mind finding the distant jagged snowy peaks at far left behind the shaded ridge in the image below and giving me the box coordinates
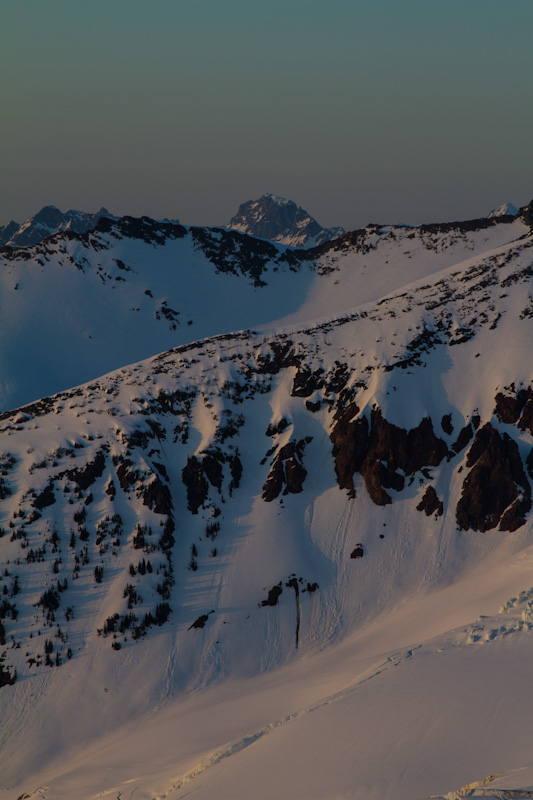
[0,206,117,247]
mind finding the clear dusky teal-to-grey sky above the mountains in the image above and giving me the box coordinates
[0,0,533,229]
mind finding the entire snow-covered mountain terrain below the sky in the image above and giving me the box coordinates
[0,195,533,800]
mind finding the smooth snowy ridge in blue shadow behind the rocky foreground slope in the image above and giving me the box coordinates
[0,212,529,410]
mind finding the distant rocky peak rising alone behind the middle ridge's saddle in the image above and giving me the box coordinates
[227,194,346,247]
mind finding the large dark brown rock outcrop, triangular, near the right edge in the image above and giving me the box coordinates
[456,422,531,532]
